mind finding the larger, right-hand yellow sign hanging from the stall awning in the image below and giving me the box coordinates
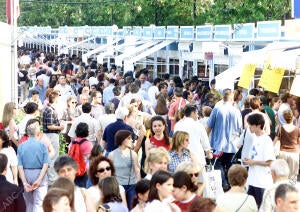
[258,66,285,93]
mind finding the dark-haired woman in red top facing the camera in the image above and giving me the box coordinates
[145,116,171,155]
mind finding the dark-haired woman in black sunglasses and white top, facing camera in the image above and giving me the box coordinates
[87,156,127,209]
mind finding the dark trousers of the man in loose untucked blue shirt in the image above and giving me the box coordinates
[213,152,234,186]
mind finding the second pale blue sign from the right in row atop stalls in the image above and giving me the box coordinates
[233,23,255,41]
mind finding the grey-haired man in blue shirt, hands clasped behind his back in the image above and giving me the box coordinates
[17,119,50,211]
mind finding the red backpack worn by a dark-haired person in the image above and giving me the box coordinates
[68,138,87,177]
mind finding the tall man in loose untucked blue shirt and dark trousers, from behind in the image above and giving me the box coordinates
[206,89,242,190]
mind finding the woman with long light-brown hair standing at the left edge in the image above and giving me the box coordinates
[2,102,19,150]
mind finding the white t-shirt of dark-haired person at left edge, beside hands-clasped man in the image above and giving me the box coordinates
[0,146,18,183]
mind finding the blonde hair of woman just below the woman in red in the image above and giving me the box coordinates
[144,147,170,173]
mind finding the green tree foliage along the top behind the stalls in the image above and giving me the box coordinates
[0,0,290,27]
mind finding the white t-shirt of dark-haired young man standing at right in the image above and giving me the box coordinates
[247,134,276,188]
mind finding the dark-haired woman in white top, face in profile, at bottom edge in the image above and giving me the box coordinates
[145,170,180,212]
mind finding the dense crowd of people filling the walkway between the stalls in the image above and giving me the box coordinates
[0,49,300,212]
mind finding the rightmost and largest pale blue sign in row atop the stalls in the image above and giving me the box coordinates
[256,21,281,40]
